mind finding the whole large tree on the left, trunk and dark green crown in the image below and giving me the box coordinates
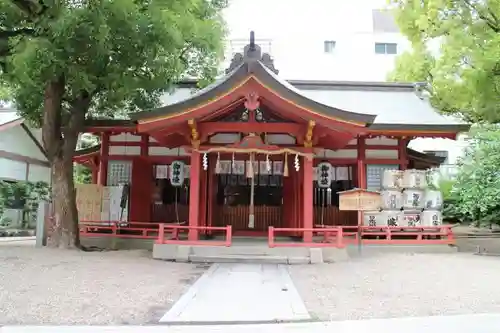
[0,0,225,248]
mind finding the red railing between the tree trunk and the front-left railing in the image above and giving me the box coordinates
[78,221,159,239]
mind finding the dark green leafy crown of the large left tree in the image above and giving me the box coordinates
[0,0,226,123]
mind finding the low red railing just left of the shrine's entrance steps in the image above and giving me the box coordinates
[156,223,233,246]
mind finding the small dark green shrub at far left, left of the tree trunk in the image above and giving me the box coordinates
[0,181,49,224]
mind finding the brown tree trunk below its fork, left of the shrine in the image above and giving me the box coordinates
[47,154,80,249]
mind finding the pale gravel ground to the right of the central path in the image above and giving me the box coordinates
[290,253,500,320]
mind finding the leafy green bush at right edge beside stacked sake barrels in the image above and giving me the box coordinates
[451,125,500,225]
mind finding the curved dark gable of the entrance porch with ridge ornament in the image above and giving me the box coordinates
[130,33,376,127]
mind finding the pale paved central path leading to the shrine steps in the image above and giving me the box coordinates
[160,264,311,323]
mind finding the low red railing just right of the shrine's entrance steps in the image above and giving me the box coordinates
[268,226,345,248]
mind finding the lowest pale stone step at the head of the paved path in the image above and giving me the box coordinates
[189,254,310,264]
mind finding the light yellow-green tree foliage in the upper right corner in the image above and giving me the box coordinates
[389,0,500,123]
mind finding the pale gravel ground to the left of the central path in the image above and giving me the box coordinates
[0,244,206,325]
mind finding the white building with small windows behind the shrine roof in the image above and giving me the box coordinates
[223,0,467,172]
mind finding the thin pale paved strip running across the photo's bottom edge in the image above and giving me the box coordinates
[0,314,500,333]
